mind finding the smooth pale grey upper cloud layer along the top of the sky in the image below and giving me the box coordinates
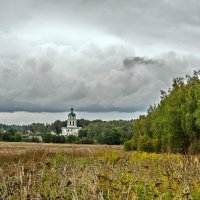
[0,0,200,52]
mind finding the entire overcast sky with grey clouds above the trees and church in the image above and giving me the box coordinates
[0,0,200,124]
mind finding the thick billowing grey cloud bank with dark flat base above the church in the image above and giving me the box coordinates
[0,44,199,112]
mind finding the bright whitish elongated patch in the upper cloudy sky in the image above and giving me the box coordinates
[16,22,122,47]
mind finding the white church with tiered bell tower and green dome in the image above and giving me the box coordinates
[61,108,81,136]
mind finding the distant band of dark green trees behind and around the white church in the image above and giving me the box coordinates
[0,119,133,145]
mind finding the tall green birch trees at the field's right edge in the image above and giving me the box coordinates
[124,71,200,153]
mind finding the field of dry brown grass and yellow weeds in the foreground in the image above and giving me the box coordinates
[0,143,200,200]
